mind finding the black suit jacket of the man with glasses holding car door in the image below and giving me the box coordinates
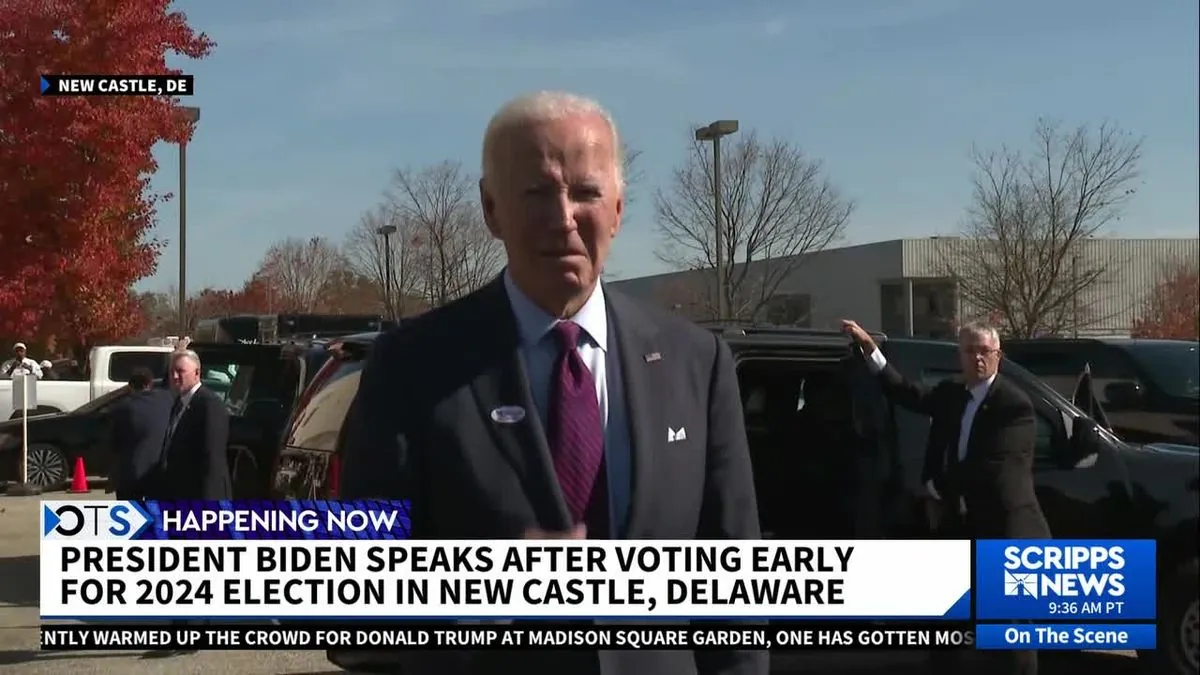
[880,364,1050,539]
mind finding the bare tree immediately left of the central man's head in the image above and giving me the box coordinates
[389,162,504,306]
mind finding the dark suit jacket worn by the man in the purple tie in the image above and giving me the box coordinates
[342,279,767,675]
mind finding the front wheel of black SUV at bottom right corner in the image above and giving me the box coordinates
[1138,560,1200,675]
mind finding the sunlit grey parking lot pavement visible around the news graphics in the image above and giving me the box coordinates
[0,491,1136,675]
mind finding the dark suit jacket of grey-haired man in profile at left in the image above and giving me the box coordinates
[155,386,233,500]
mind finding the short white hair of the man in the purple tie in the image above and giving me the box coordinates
[481,91,625,187]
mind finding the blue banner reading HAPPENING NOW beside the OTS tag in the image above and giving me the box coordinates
[137,500,409,539]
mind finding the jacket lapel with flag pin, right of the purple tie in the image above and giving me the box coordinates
[605,288,671,537]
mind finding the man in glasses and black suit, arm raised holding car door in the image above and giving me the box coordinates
[842,321,1050,675]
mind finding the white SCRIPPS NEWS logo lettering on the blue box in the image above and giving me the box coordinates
[1004,544,1126,598]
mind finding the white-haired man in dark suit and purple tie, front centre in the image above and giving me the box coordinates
[342,92,767,675]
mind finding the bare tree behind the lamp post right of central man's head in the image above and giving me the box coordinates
[654,132,853,319]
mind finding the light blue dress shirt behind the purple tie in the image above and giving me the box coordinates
[504,270,632,538]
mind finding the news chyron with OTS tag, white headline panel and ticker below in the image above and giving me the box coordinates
[40,501,973,649]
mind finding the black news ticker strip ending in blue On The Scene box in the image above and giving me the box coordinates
[41,622,1157,651]
